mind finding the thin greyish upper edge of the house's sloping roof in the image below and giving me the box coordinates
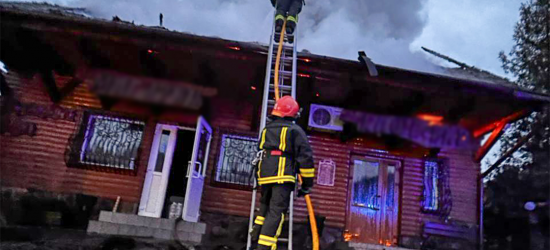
[0,2,550,107]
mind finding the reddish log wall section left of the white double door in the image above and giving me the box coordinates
[0,71,197,204]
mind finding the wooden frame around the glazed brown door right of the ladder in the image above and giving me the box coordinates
[350,153,405,246]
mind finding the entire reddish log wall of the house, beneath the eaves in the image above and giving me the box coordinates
[0,71,479,241]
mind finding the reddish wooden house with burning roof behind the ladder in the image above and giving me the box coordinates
[0,3,550,249]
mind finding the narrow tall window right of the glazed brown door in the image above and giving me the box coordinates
[422,159,440,212]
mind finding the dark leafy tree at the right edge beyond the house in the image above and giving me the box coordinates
[484,0,550,249]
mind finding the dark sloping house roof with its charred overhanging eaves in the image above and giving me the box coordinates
[0,2,550,133]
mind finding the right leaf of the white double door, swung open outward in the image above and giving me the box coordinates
[182,116,212,222]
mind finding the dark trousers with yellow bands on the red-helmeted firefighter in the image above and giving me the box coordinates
[254,183,294,250]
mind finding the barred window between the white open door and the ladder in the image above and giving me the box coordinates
[215,134,258,187]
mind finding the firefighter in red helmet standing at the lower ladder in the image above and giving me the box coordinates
[251,96,315,250]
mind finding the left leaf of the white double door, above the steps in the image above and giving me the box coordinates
[138,124,178,218]
